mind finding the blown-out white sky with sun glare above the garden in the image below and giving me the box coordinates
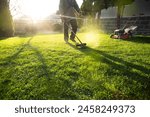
[11,0,83,20]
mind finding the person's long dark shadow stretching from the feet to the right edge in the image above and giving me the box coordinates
[69,44,150,77]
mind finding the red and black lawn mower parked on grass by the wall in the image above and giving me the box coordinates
[110,17,138,39]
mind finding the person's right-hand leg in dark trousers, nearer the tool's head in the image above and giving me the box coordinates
[70,19,78,41]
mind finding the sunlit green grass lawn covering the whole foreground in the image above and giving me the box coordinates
[0,33,150,100]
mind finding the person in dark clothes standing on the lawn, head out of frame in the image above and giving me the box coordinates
[59,0,80,43]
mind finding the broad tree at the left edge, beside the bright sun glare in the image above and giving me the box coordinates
[0,0,14,37]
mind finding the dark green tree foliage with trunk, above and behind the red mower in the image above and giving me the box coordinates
[81,0,134,28]
